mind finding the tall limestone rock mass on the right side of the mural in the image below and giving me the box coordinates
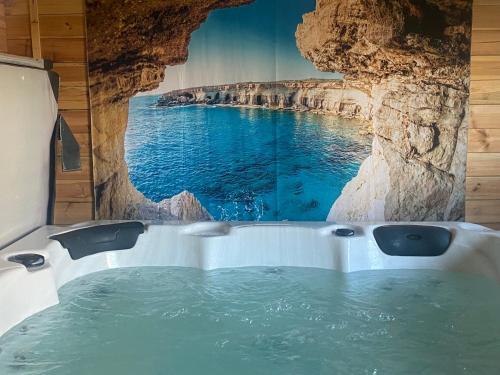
[296,0,472,221]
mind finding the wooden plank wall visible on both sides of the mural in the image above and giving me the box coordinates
[0,0,500,229]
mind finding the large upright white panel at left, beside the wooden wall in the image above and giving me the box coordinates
[0,54,57,247]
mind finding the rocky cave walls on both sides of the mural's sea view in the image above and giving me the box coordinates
[87,0,472,221]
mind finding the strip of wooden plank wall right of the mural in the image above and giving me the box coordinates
[466,0,500,229]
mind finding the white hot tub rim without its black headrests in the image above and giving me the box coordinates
[0,222,500,335]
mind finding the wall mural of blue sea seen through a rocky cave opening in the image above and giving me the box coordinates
[86,0,472,221]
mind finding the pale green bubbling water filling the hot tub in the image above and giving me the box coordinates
[0,267,500,375]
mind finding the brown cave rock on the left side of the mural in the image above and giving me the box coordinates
[86,0,253,220]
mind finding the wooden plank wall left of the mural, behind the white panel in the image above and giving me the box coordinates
[4,0,93,224]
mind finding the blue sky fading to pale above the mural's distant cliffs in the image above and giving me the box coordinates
[146,0,341,95]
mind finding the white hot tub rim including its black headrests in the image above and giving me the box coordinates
[0,222,500,373]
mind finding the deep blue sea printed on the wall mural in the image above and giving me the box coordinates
[125,96,371,220]
